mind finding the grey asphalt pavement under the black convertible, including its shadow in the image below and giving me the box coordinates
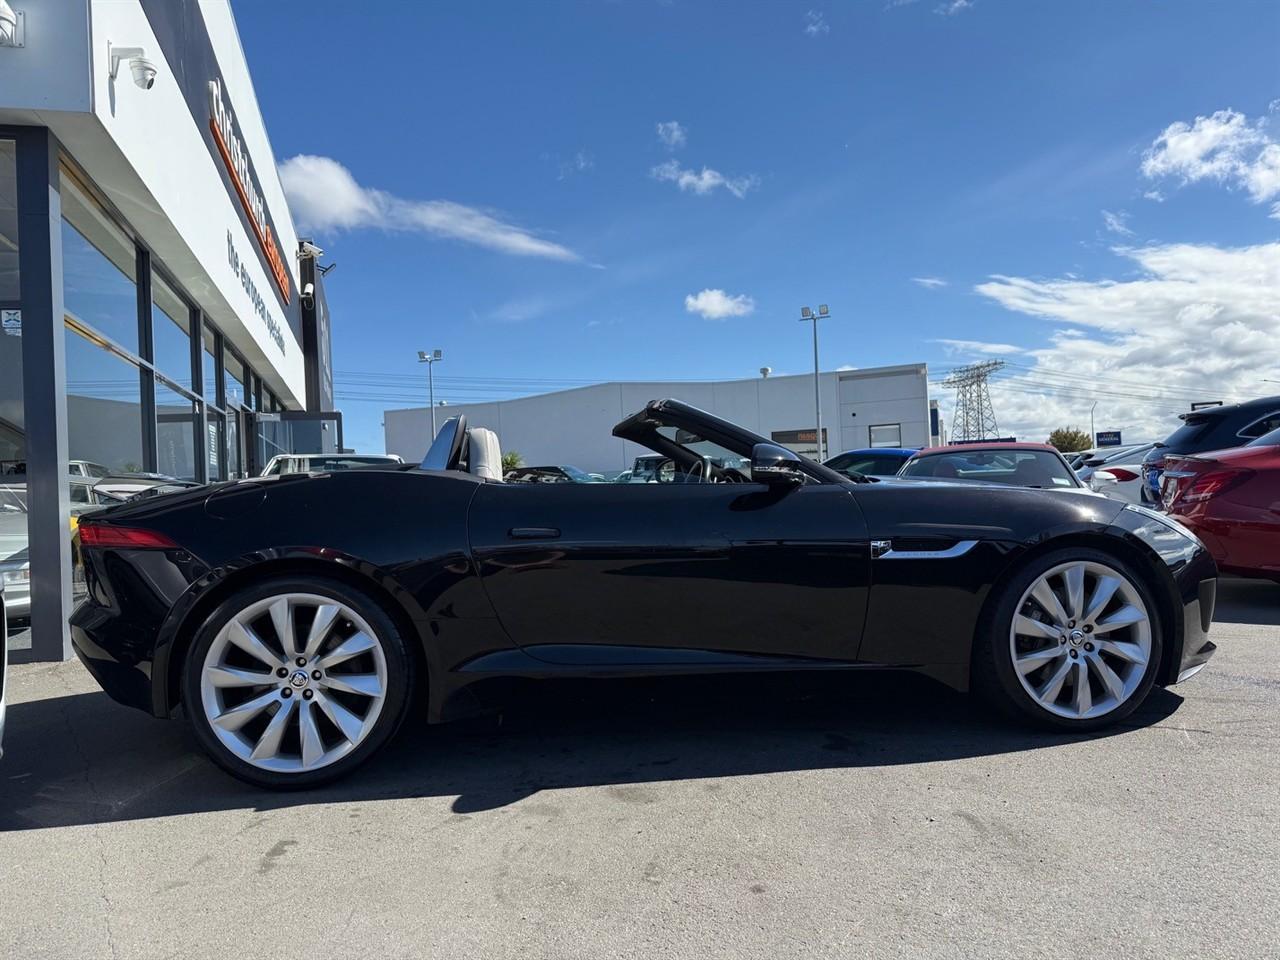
[0,581,1280,960]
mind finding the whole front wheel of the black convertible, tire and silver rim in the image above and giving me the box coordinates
[973,548,1162,730]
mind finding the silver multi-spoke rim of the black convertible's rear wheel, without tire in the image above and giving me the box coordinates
[200,593,387,773]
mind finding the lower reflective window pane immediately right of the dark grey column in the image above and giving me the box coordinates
[67,326,143,474]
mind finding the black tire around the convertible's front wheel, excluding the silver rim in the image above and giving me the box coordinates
[970,547,1165,732]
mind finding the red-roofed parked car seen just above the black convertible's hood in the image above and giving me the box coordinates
[897,442,1083,489]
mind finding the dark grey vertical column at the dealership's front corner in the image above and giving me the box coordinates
[17,127,72,660]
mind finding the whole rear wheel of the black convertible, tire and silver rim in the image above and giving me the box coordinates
[183,579,413,788]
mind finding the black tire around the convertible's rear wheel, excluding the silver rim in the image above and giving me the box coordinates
[182,577,416,790]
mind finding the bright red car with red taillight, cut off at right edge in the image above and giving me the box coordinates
[1161,430,1280,582]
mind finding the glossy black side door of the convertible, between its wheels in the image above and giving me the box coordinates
[470,483,870,663]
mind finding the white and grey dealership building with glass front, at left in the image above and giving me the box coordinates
[0,0,340,659]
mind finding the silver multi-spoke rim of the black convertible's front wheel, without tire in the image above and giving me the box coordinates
[1009,561,1151,719]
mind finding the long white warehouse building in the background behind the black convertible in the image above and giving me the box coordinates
[383,364,938,472]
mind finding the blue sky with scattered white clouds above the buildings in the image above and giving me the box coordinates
[234,0,1280,449]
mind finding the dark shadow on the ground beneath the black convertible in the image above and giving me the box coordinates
[0,673,1181,831]
